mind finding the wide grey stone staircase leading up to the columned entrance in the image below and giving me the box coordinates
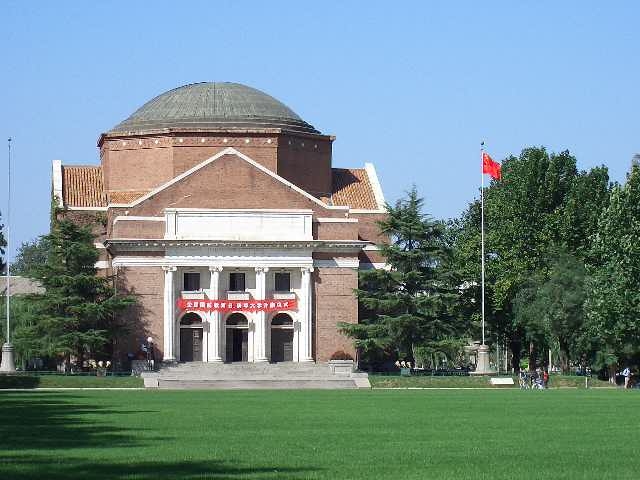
[142,362,371,390]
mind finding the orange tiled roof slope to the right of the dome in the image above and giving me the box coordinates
[331,168,378,210]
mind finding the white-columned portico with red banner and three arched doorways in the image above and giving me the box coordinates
[162,262,313,363]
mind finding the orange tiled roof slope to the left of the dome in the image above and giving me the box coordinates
[62,165,107,207]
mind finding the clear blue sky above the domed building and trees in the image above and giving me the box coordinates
[0,1,640,255]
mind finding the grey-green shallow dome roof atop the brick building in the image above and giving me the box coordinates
[109,82,320,133]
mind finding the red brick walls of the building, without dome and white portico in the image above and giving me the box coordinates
[54,81,385,362]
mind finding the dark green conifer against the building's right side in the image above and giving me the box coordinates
[340,188,460,368]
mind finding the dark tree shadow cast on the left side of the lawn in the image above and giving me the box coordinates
[0,391,317,480]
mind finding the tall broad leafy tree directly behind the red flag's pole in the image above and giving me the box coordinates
[455,148,610,369]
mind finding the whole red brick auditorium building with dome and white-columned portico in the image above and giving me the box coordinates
[53,82,385,363]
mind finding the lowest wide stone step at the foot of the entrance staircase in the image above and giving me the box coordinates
[158,378,358,390]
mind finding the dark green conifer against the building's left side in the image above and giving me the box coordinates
[30,216,135,365]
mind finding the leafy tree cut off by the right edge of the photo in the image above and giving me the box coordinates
[583,165,640,381]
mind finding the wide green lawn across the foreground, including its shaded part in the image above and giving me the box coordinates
[0,390,640,480]
